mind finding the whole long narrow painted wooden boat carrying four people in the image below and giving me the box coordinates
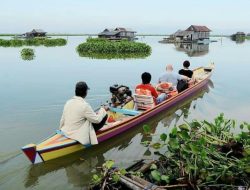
[22,66,213,164]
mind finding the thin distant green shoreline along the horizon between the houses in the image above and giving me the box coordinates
[0,33,230,37]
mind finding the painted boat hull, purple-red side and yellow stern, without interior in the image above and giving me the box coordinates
[22,69,211,164]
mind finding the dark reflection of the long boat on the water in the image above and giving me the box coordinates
[24,81,213,188]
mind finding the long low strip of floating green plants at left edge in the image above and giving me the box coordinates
[0,38,67,47]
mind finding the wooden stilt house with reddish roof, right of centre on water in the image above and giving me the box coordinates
[170,25,211,42]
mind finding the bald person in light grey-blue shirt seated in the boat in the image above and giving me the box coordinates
[158,64,190,88]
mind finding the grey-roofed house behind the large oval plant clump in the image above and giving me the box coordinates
[98,27,136,40]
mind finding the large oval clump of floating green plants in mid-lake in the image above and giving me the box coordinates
[76,38,151,59]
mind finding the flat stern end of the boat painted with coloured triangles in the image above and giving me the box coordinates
[22,144,43,164]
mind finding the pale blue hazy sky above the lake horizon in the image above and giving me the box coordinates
[0,0,250,34]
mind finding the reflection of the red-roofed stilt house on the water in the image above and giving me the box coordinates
[174,43,209,57]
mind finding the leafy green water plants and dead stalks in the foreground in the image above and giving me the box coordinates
[93,114,250,190]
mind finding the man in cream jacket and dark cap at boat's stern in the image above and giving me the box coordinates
[59,82,107,144]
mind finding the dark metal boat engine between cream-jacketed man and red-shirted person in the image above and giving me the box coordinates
[109,84,132,107]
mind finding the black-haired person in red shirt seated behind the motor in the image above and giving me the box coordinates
[135,72,167,104]
